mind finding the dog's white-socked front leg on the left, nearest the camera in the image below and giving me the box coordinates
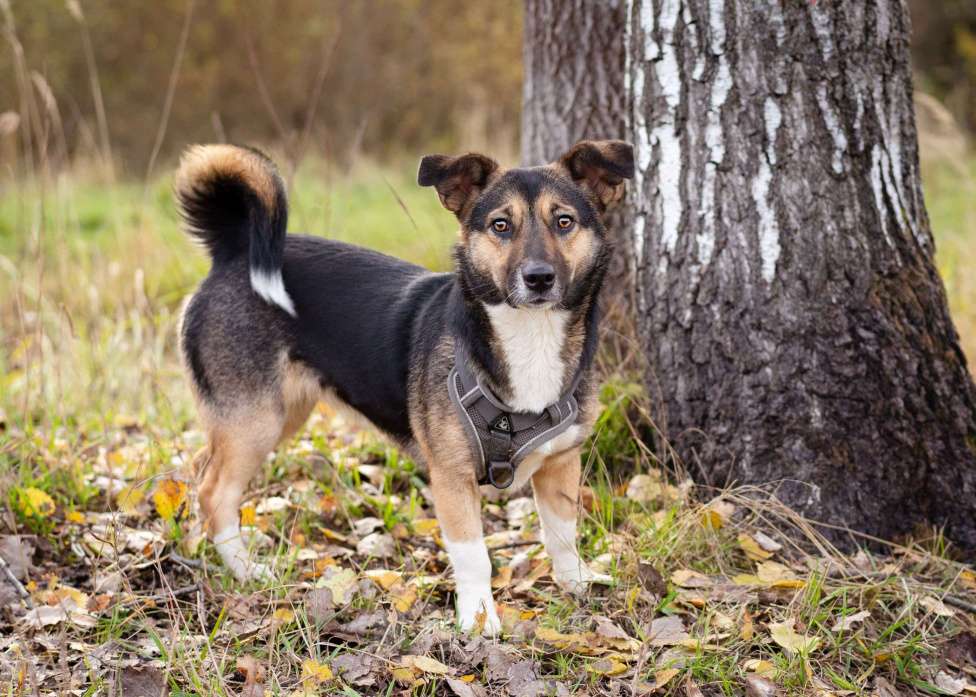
[431,467,501,636]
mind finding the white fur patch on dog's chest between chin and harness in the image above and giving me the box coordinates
[485,303,569,412]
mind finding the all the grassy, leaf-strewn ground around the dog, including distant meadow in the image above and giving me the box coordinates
[0,158,976,697]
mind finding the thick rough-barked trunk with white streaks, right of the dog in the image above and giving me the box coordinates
[624,0,976,555]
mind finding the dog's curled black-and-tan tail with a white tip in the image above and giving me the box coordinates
[175,145,295,316]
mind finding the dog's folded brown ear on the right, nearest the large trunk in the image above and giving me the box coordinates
[558,140,634,212]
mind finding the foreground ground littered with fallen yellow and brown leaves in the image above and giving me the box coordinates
[0,388,976,697]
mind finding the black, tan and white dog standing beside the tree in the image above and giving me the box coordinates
[175,141,634,635]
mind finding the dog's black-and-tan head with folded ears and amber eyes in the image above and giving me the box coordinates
[417,140,634,309]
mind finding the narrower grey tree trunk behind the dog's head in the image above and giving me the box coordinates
[522,0,633,316]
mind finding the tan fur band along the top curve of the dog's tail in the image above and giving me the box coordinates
[175,145,277,212]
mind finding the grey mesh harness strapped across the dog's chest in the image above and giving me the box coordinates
[447,351,582,489]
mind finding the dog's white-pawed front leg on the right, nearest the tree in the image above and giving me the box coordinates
[532,448,610,593]
